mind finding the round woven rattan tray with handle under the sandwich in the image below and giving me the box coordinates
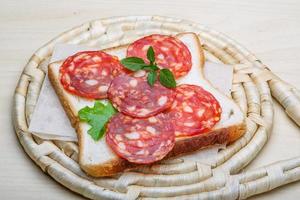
[13,16,300,199]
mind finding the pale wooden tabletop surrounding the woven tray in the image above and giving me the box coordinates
[0,0,300,200]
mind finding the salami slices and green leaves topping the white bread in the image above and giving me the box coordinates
[60,34,222,164]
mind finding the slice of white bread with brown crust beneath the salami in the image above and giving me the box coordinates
[48,33,246,177]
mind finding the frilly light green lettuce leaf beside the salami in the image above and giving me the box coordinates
[78,101,117,141]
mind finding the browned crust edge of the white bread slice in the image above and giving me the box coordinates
[48,32,246,177]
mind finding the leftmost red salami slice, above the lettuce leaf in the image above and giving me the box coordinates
[60,51,125,99]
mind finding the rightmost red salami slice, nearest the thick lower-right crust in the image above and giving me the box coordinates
[167,84,222,137]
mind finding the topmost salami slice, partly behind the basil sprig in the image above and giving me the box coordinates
[127,34,192,78]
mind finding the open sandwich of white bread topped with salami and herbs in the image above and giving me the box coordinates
[48,33,246,177]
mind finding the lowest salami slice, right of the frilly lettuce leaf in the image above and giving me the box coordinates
[106,113,175,164]
